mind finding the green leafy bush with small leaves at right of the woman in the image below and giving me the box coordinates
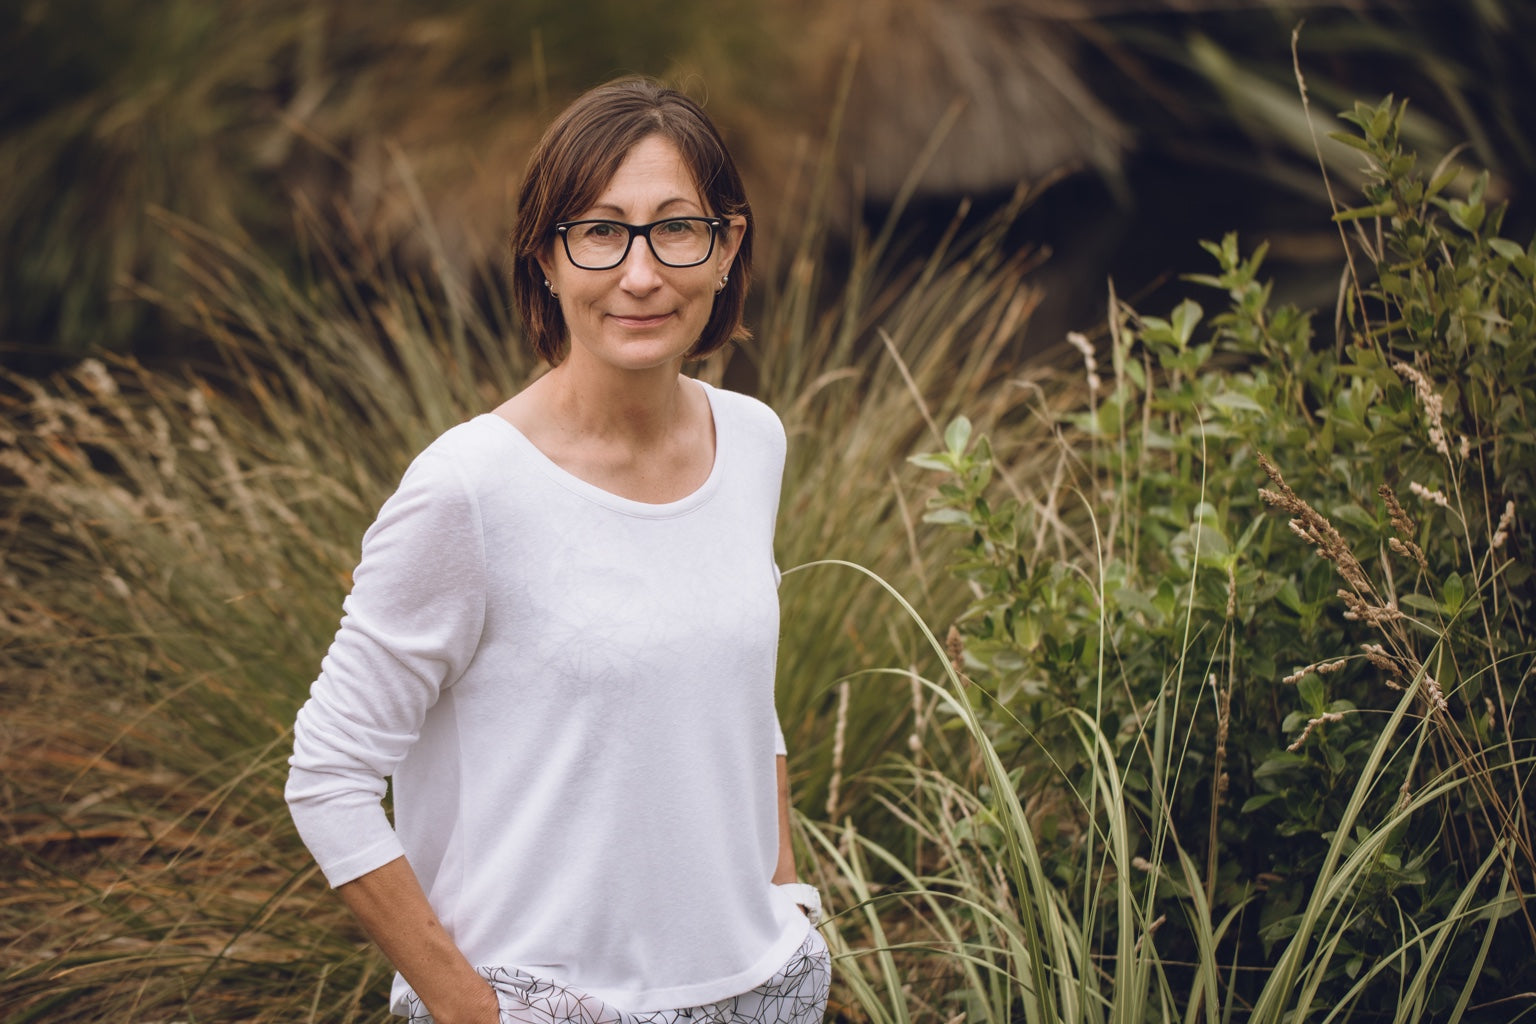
[897,98,1536,1019]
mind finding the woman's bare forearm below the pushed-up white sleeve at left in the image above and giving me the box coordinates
[336,857,499,1024]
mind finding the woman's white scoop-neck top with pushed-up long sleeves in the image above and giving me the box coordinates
[287,387,808,1012]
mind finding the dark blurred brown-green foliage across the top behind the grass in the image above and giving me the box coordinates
[0,0,1536,370]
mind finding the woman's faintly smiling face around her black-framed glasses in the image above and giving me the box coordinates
[539,135,745,370]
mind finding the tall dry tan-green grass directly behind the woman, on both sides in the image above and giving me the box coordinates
[0,128,1056,1024]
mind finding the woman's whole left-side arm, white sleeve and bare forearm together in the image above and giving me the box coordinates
[286,445,498,1024]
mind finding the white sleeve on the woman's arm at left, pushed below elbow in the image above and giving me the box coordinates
[286,448,485,886]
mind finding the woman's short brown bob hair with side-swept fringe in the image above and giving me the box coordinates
[511,77,753,365]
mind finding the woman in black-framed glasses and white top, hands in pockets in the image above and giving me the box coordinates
[287,78,829,1024]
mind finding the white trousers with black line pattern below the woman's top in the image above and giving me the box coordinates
[407,929,833,1024]
